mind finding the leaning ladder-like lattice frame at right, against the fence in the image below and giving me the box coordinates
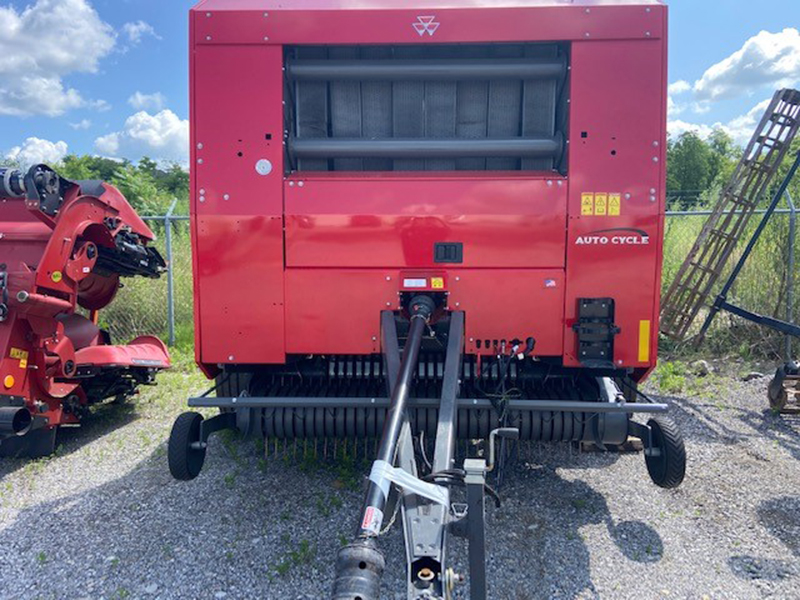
[661,89,800,340]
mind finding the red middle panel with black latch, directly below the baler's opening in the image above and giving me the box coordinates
[285,175,567,268]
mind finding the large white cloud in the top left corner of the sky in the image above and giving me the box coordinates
[0,0,116,117]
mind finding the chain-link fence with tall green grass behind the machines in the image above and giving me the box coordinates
[100,194,800,358]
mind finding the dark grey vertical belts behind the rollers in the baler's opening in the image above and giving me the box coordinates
[286,44,568,171]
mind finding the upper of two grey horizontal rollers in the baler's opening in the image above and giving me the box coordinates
[286,57,567,81]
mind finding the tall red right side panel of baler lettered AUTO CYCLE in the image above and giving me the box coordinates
[564,40,666,369]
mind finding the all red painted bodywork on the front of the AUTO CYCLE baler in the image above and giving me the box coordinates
[190,0,667,376]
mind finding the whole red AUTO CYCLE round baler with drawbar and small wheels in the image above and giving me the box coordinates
[168,0,685,600]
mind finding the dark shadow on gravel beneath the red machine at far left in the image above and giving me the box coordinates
[0,402,138,477]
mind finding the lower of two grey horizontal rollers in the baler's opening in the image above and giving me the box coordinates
[289,133,564,159]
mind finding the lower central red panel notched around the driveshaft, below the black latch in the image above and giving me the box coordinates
[286,269,564,356]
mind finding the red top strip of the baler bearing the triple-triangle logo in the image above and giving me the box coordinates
[193,1,666,45]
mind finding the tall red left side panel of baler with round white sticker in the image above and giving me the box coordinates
[192,46,285,364]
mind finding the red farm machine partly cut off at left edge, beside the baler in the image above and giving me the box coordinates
[0,165,170,457]
